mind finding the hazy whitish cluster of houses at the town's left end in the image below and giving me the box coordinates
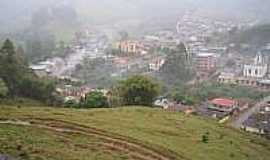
[30,28,109,78]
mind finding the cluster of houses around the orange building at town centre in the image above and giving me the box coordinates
[110,31,177,75]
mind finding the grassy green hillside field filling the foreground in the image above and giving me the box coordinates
[0,106,270,160]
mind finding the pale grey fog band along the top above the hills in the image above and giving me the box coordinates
[0,0,270,32]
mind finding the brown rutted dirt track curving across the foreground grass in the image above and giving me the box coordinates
[0,119,187,160]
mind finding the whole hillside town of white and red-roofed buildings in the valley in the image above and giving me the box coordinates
[23,12,270,137]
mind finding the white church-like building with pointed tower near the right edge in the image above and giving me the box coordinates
[243,53,268,78]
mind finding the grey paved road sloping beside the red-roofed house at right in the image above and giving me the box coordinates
[231,96,270,128]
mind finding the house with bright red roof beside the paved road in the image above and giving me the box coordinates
[208,98,238,112]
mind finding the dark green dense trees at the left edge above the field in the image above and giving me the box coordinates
[0,40,55,102]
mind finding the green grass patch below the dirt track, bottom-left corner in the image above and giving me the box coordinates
[0,125,125,160]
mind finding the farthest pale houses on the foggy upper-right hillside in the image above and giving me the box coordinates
[176,11,254,42]
